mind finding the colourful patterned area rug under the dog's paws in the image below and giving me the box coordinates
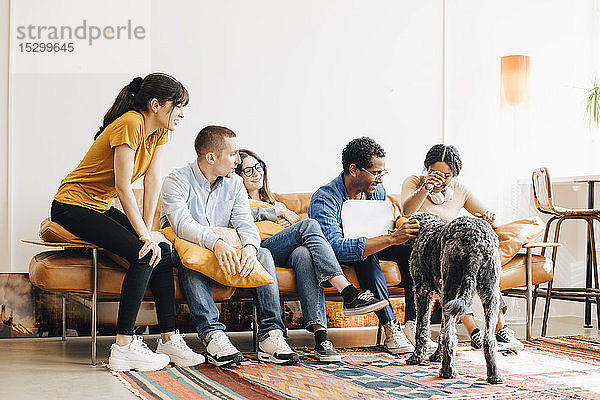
[114,337,600,400]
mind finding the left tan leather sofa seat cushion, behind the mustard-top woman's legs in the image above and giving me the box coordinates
[29,250,235,302]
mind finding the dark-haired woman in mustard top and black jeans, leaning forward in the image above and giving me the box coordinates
[51,73,204,371]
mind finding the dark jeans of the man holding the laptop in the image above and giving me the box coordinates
[344,245,416,324]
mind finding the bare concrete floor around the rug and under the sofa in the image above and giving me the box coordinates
[0,317,600,400]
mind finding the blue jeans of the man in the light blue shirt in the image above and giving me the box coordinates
[179,248,285,339]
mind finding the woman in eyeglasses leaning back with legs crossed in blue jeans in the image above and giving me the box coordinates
[236,150,388,362]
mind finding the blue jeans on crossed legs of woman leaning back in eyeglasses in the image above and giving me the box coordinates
[261,219,343,331]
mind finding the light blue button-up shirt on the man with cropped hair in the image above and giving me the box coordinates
[160,161,260,250]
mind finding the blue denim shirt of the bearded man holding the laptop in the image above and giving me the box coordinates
[308,172,386,262]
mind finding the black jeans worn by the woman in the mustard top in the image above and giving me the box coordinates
[50,200,177,335]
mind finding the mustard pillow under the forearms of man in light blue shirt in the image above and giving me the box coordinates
[161,227,274,288]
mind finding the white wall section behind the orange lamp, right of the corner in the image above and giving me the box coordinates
[446,0,600,322]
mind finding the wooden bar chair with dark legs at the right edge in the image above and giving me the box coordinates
[531,168,600,336]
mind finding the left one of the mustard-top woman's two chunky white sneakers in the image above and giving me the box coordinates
[108,335,170,371]
